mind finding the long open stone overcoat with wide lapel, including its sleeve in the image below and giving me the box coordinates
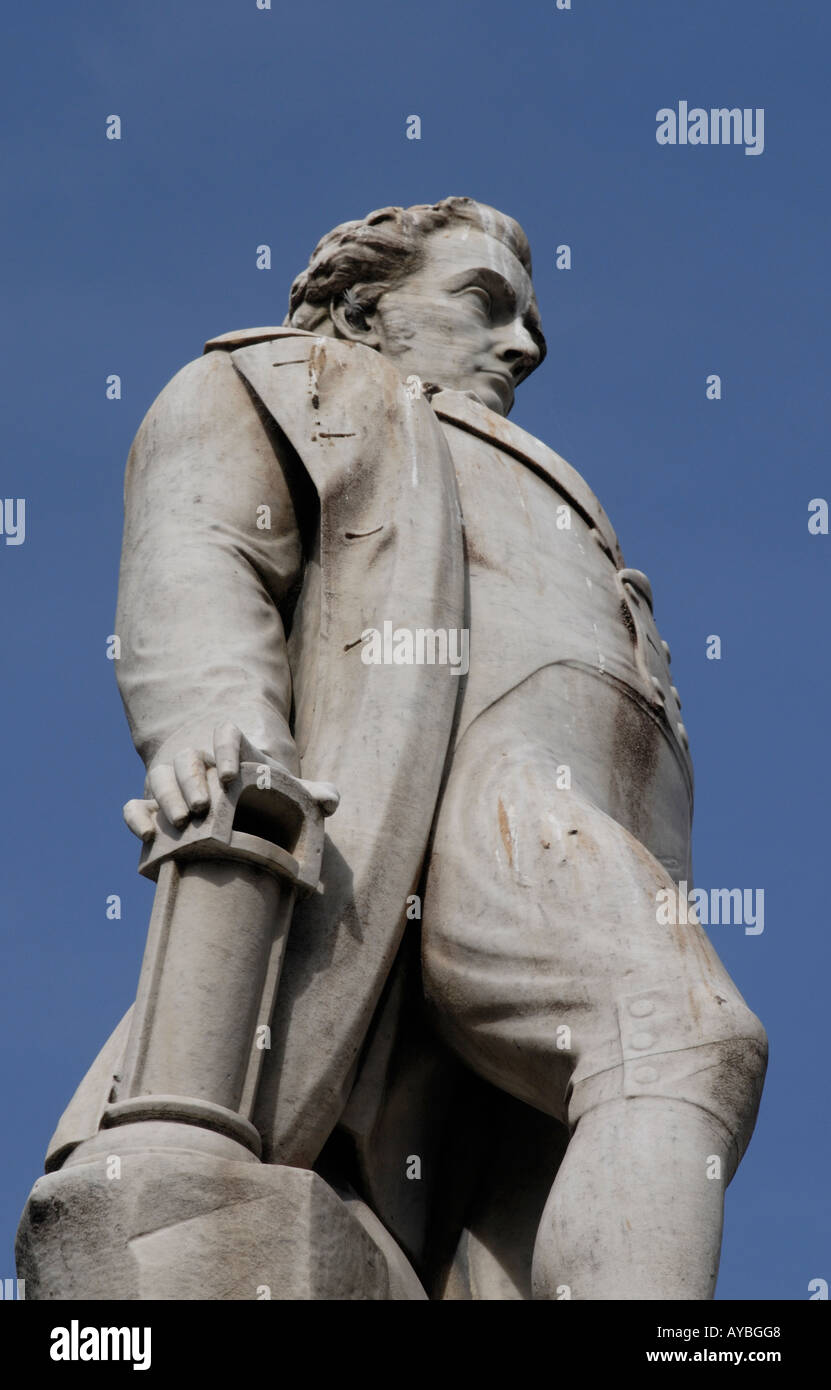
[47,328,466,1168]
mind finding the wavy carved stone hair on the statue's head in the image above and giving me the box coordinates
[283,197,541,331]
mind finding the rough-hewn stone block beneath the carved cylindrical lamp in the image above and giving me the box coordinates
[18,1131,424,1300]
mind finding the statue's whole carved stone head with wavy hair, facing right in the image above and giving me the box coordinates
[286,197,546,414]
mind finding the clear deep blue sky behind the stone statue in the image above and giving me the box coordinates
[0,0,831,1300]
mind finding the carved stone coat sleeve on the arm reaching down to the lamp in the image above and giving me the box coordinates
[115,353,303,773]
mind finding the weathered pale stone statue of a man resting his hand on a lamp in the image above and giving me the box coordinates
[18,197,766,1300]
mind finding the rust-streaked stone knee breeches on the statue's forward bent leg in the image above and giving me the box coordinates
[422,667,767,1161]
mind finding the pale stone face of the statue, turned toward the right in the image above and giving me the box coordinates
[334,222,542,416]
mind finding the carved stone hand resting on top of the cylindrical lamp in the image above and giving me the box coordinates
[124,721,275,840]
